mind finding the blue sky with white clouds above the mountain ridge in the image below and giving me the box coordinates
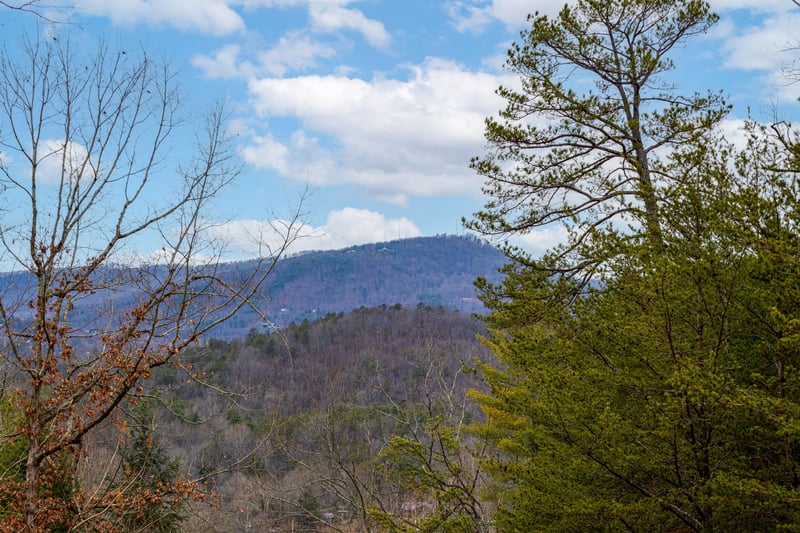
[0,0,800,259]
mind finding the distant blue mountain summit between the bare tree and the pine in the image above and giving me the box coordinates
[215,236,506,338]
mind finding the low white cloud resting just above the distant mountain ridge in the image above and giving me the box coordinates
[211,207,421,258]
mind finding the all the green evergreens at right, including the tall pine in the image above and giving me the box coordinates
[466,0,800,532]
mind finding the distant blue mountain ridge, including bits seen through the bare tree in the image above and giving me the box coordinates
[0,236,506,340]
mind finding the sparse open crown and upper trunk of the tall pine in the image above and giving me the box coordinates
[467,0,729,273]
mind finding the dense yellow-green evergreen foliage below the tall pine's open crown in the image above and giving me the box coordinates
[475,149,800,531]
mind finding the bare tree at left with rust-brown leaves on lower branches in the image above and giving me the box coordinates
[0,34,302,531]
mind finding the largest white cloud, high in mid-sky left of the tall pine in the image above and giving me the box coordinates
[244,59,516,204]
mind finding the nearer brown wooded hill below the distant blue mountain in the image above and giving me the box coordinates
[94,305,488,532]
